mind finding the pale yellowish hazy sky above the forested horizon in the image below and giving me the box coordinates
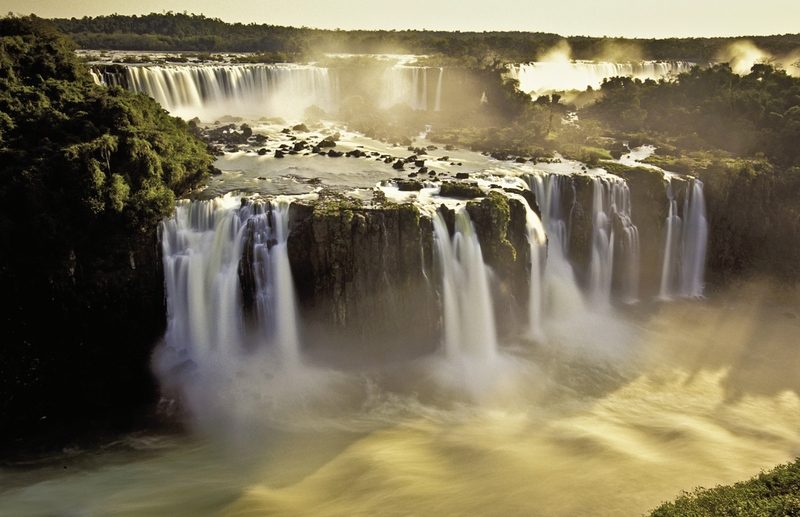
[6,0,800,37]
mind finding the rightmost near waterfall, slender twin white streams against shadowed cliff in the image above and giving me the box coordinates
[659,179,708,300]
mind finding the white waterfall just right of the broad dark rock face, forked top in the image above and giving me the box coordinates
[433,207,497,359]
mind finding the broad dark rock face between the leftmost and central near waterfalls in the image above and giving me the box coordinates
[288,194,438,354]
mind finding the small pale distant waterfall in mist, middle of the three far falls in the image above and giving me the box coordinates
[380,65,444,111]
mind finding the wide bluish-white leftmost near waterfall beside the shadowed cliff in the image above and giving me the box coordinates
[161,195,300,367]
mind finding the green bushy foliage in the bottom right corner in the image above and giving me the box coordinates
[651,459,800,517]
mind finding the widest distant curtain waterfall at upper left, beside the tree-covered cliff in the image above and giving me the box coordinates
[93,64,338,122]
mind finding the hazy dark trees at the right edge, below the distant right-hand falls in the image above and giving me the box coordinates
[586,65,800,165]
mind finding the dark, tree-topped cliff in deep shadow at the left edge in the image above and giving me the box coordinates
[0,18,212,444]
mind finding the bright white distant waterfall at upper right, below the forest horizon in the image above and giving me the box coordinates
[508,61,694,94]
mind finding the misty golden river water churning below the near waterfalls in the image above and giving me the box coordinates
[0,287,800,516]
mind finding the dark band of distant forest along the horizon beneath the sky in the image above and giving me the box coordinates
[45,12,800,62]
